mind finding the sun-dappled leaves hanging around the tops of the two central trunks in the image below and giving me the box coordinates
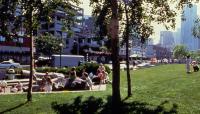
[91,0,177,43]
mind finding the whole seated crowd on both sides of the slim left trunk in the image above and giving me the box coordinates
[0,63,111,93]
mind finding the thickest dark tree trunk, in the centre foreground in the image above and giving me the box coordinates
[109,0,121,113]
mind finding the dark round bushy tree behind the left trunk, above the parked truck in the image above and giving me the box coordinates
[35,34,63,57]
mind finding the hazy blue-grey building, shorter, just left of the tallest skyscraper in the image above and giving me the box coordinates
[160,31,174,50]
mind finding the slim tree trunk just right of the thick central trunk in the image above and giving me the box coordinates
[125,3,132,97]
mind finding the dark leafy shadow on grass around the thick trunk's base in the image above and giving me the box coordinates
[52,96,178,114]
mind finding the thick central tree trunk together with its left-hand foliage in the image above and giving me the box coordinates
[91,0,121,110]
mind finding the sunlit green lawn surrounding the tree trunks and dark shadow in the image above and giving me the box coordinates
[0,64,200,114]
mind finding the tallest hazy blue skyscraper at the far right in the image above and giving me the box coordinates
[181,5,200,51]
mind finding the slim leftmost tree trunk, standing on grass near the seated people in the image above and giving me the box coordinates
[27,1,34,101]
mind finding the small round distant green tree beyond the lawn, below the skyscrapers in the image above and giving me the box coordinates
[173,45,189,59]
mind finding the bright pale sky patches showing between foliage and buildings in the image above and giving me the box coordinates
[80,0,186,44]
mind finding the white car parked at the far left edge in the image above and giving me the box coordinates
[0,60,21,68]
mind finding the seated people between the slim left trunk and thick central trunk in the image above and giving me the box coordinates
[33,64,111,92]
